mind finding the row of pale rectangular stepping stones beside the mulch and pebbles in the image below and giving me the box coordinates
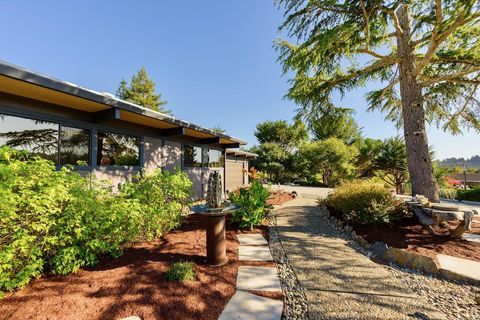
[219,234,283,320]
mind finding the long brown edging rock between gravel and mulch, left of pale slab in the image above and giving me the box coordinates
[383,248,440,273]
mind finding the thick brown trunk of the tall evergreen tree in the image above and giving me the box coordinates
[397,5,439,202]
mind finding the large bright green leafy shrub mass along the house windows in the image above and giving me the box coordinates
[0,147,191,291]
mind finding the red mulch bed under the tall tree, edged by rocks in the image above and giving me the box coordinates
[329,208,480,261]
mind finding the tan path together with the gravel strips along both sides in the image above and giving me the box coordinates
[270,199,480,319]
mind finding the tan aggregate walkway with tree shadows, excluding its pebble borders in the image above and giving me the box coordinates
[276,199,444,319]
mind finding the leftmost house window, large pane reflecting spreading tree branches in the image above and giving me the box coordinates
[0,114,58,164]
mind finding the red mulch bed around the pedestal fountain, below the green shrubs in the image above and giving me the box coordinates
[0,214,282,320]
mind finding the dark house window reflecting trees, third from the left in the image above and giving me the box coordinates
[97,131,140,166]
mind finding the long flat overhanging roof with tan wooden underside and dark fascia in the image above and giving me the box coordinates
[0,60,246,148]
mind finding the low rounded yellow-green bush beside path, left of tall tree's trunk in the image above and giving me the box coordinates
[324,181,405,224]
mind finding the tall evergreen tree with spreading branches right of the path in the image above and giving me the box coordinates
[277,0,480,201]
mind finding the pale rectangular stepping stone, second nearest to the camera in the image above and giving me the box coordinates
[237,267,282,291]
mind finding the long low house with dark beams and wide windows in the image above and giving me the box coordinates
[0,61,251,199]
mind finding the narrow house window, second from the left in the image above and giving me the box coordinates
[60,126,90,165]
